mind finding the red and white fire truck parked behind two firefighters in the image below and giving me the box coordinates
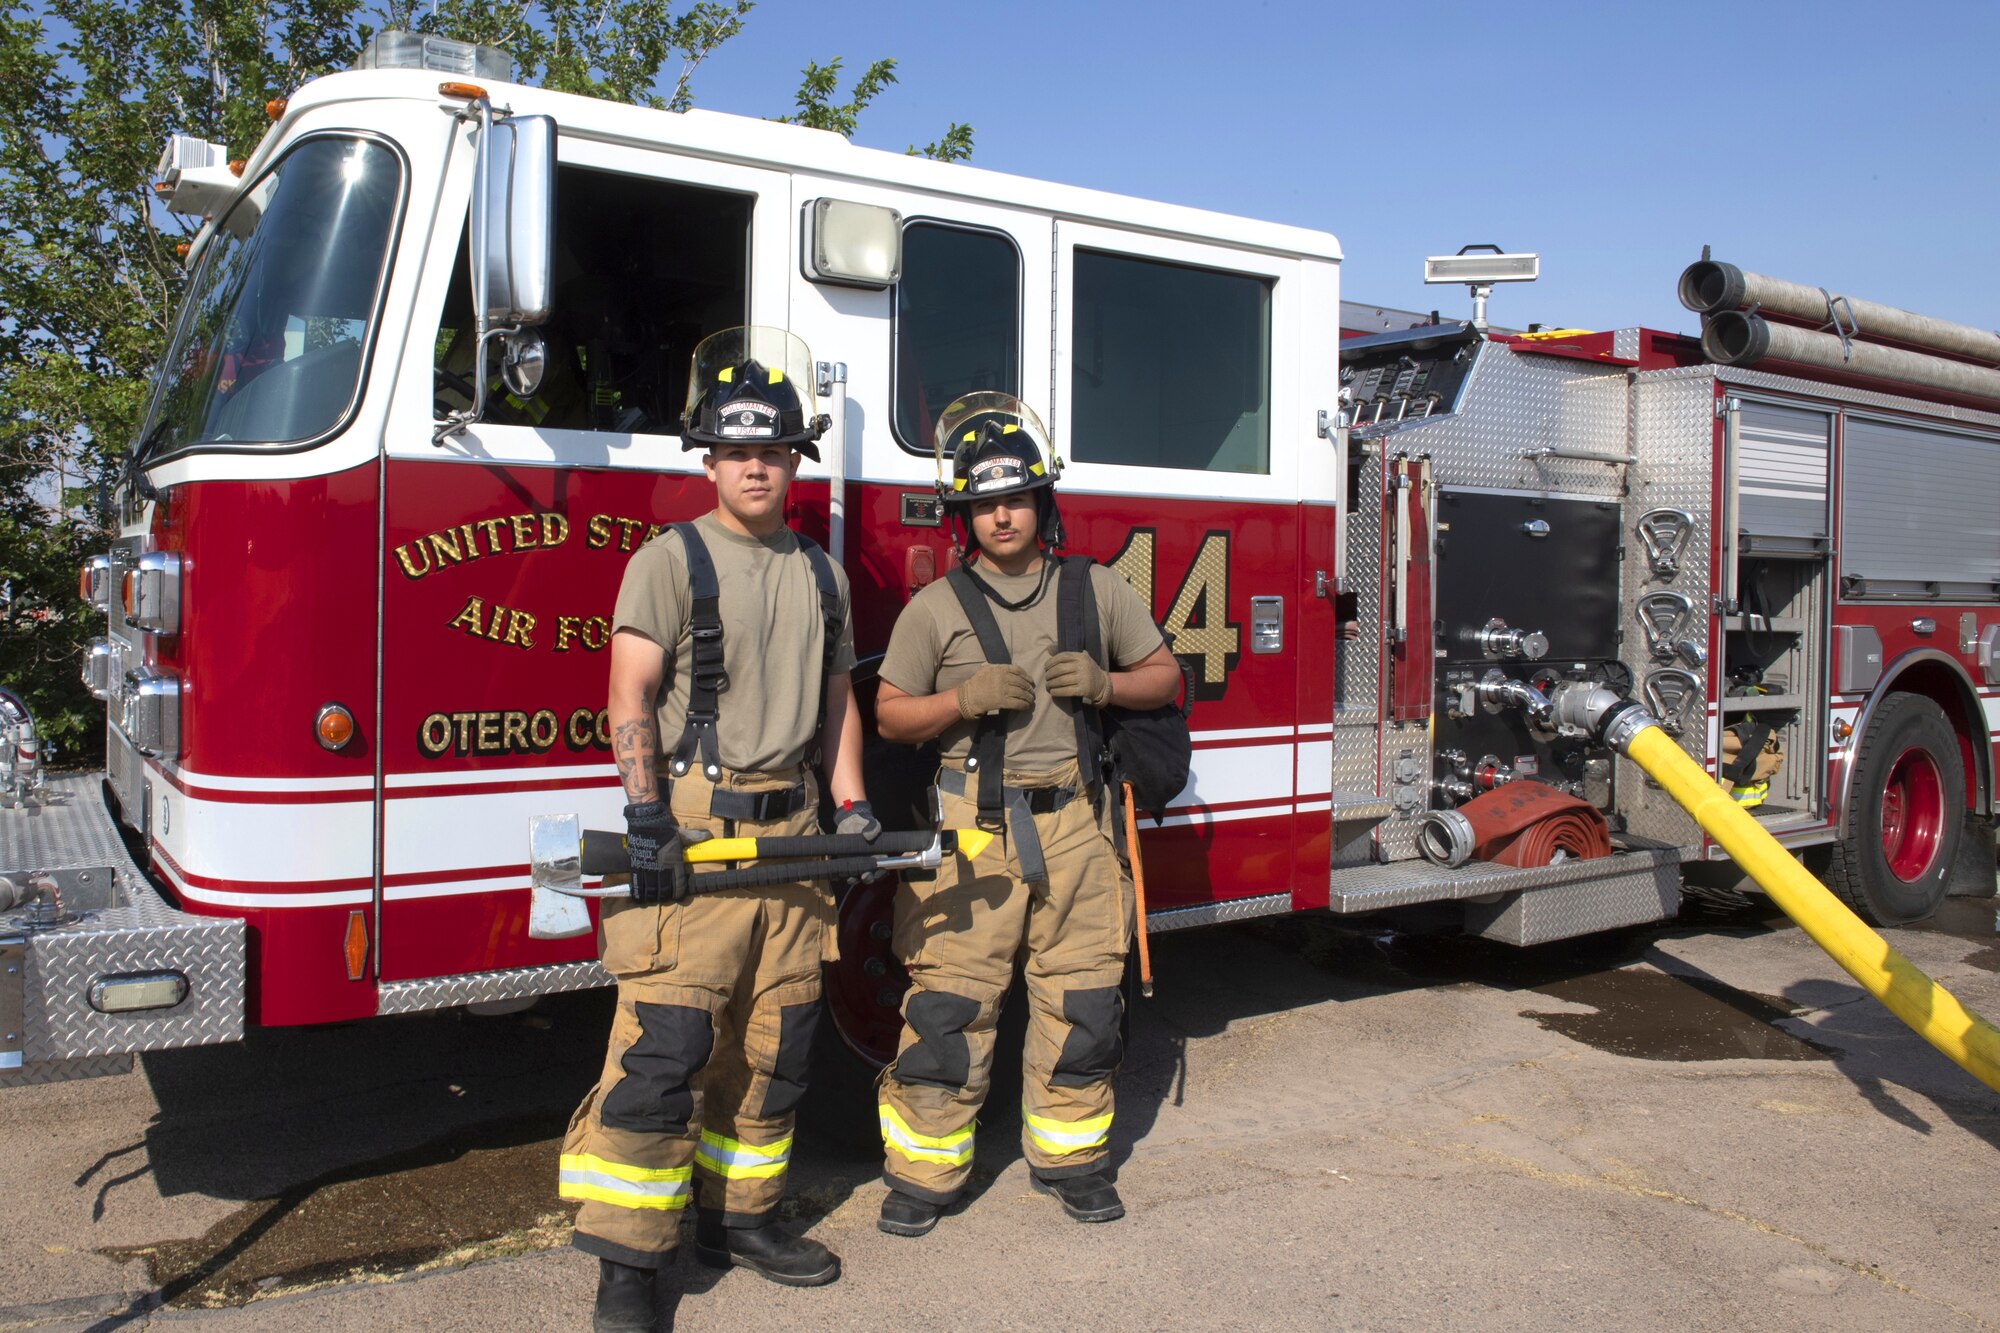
[0,34,2000,1081]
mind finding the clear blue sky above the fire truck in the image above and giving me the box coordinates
[694,0,2000,332]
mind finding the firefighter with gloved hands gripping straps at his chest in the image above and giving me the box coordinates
[876,394,1180,1237]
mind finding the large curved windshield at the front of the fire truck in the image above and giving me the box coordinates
[140,138,402,456]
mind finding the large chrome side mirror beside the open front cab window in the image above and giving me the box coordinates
[472,116,556,326]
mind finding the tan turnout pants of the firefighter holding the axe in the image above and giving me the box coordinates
[560,769,834,1267]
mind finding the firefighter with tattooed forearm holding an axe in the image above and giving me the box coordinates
[560,328,880,1329]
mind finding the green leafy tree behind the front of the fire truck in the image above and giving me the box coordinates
[0,0,972,753]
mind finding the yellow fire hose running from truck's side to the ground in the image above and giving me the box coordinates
[1612,719,2000,1093]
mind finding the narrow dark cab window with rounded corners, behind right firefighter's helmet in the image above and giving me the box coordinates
[896,222,1020,456]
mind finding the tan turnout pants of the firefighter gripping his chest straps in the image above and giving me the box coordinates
[878,765,1134,1203]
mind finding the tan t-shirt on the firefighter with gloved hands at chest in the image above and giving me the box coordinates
[882,560,1166,773]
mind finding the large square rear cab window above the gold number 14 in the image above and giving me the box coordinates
[1068,248,1270,474]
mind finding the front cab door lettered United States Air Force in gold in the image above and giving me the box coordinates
[378,135,794,980]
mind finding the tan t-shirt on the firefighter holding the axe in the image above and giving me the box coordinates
[612,512,854,773]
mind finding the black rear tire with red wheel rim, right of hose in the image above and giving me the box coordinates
[1826,695,1966,925]
